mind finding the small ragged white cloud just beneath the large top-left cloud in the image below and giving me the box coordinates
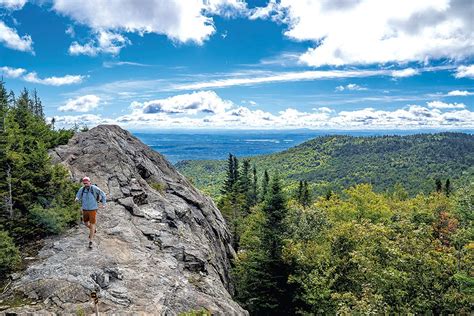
[69,31,131,56]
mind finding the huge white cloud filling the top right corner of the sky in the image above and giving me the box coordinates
[254,0,474,66]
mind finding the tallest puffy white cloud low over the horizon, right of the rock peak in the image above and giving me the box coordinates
[132,91,233,115]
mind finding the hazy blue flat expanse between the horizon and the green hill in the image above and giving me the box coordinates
[132,130,472,164]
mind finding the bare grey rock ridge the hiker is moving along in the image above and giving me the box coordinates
[2,125,248,315]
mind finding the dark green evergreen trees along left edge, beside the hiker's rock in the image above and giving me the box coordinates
[0,81,80,283]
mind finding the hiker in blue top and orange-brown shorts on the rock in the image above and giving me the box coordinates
[76,177,106,248]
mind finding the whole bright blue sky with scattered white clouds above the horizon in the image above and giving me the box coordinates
[0,0,474,131]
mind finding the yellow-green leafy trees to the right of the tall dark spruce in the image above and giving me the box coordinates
[284,185,474,314]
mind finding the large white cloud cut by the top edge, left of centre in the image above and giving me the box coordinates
[53,0,246,45]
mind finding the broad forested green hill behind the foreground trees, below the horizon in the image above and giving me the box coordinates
[176,132,474,197]
